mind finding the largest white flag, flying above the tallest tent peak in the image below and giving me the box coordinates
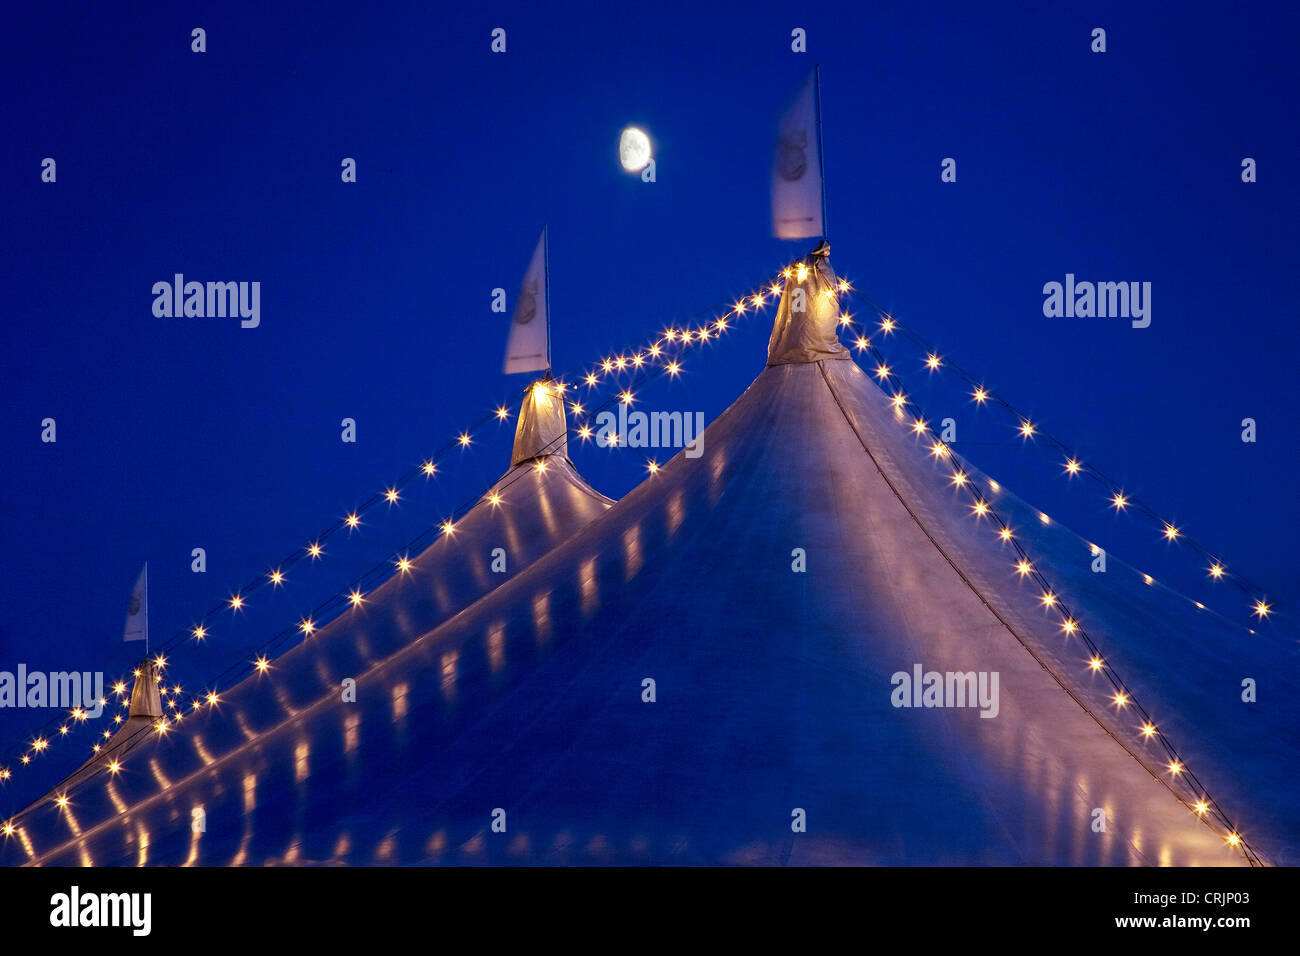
[772,70,826,239]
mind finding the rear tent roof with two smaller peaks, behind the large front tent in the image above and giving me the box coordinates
[0,382,612,862]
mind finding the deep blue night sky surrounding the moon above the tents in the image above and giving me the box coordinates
[0,1,1300,801]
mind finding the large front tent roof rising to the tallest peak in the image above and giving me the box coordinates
[9,252,1300,865]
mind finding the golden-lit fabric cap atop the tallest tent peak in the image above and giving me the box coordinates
[767,247,849,365]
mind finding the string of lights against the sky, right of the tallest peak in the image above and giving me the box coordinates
[841,290,1275,633]
